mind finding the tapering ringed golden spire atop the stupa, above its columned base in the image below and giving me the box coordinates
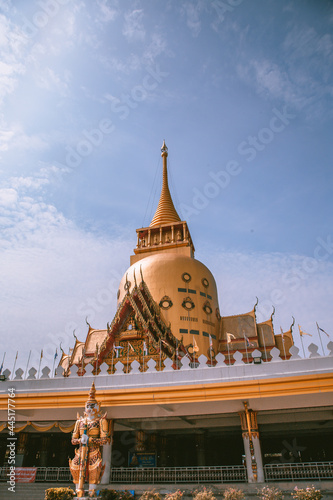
[150,141,181,227]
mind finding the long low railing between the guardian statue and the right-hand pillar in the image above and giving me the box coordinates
[110,465,247,484]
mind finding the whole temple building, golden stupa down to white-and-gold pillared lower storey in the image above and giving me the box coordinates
[0,143,333,483]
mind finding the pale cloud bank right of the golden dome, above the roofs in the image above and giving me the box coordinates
[206,247,333,333]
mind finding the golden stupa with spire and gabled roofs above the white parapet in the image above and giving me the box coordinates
[60,142,293,374]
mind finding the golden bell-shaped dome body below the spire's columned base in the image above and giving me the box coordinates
[118,252,220,356]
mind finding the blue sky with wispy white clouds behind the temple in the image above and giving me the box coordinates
[0,0,333,368]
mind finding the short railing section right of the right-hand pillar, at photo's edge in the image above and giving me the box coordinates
[264,462,333,482]
